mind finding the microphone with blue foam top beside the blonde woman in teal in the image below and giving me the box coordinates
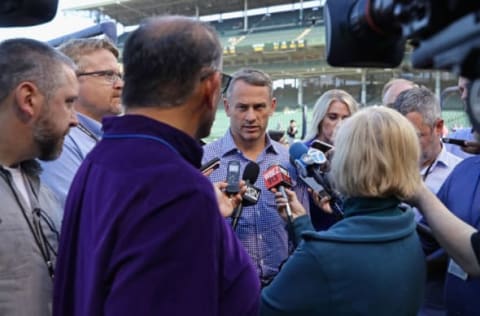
[289,142,343,217]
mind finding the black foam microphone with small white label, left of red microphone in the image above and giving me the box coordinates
[232,161,261,230]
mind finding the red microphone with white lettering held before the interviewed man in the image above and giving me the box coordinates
[263,165,297,247]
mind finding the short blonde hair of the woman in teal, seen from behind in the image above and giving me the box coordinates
[331,106,421,199]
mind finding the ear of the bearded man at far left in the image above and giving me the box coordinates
[14,81,43,120]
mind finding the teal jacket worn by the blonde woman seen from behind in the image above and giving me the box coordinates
[261,198,425,316]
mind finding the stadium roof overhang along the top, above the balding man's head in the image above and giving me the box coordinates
[63,0,308,26]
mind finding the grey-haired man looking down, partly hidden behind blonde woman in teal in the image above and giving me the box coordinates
[393,88,461,315]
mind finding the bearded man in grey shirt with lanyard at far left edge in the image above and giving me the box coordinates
[0,39,78,316]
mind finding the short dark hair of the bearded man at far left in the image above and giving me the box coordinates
[0,38,76,102]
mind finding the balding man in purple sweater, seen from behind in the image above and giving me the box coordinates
[54,16,259,316]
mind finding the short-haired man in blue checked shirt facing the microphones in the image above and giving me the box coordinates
[203,69,308,285]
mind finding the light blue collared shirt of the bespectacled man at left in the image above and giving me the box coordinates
[39,112,102,208]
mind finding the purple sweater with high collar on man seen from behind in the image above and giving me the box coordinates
[53,115,260,316]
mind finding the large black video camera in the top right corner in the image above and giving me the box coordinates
[324,0,480,132]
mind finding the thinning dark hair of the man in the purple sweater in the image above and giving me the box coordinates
[122,16,222,108]
